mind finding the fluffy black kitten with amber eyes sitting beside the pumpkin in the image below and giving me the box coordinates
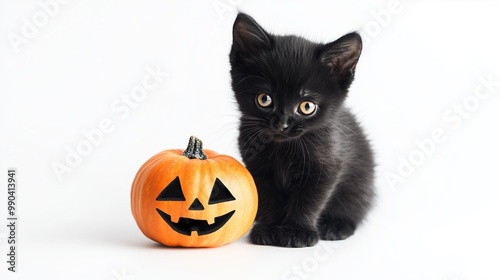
[229,13,374,247]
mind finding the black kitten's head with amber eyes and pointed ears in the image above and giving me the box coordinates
[229,13,362,142]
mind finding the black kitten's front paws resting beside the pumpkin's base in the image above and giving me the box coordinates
[250,224,319,248]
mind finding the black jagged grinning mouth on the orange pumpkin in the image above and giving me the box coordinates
[156,208,236,236]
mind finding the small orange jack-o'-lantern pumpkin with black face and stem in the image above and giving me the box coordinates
[131,137,257,247]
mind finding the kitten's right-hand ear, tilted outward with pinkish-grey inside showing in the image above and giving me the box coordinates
[321,32,363,82]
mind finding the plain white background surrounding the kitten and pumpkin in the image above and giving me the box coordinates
[0,0,500,280]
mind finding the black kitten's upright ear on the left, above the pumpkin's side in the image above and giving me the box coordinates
[233,13,271,53]
